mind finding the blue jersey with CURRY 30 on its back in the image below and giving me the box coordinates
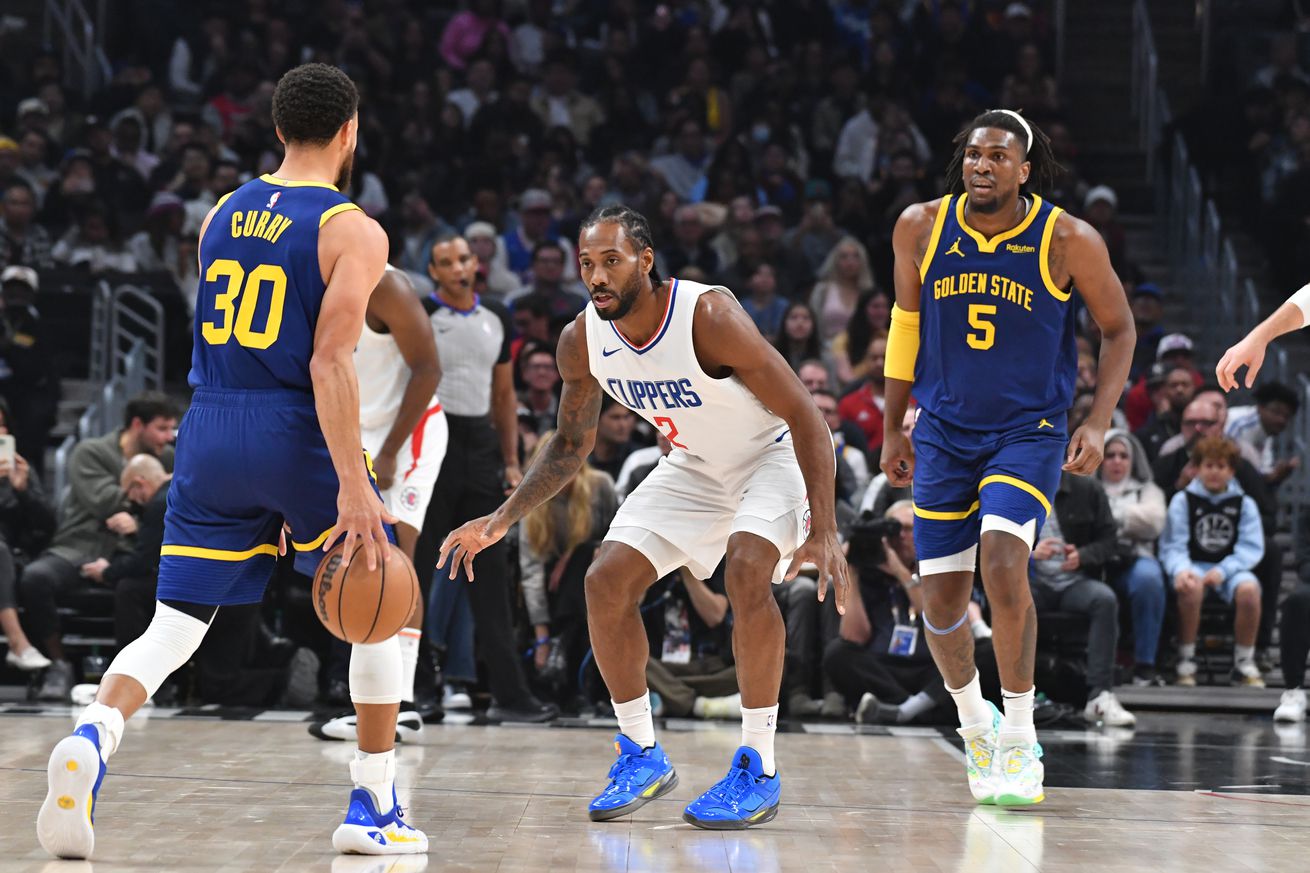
[189,176,359,392]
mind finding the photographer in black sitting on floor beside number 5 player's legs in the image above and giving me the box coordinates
[824,499,1000,724]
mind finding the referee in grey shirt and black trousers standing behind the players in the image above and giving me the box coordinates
[414,235,559,721]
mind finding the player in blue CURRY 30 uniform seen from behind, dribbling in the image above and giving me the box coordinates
[37,64,427,859]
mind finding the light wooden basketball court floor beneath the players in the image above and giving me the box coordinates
[0,705,1310,873]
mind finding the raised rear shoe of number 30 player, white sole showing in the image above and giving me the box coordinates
[37,725,106,859]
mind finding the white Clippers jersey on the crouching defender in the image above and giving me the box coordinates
[587,279,787,469]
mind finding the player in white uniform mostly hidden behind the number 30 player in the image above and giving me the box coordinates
[309,265,447,741]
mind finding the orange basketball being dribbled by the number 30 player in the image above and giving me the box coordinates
[312,543,419,642]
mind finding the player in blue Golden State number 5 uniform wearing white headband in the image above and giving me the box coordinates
[882,110,1136,806]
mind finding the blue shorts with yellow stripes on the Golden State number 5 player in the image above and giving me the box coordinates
[910,410,1069,561]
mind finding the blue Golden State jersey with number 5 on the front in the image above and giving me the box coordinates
[913,194,1078,431]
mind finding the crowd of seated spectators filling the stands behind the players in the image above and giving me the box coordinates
[0,0,1310,725]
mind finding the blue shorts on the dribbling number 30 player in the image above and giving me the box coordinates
[156,388,394,606]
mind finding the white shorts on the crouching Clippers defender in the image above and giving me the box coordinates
[605,439,810,582]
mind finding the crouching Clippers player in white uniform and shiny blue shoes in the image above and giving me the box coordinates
[439,206,848,830]
